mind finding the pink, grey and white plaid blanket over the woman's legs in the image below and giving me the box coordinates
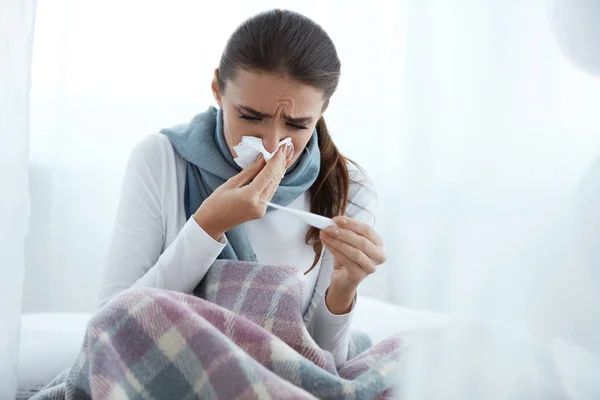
[34,261,403,400]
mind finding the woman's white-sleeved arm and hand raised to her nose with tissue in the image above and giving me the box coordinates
[100,134,290,305]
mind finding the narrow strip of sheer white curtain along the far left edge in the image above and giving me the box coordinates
[0,0,36,399]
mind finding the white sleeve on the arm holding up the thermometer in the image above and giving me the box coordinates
[304,164,377,366]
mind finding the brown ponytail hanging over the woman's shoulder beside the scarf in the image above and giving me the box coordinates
[304,117,350,275]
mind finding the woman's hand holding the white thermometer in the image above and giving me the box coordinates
[320,217,386,297]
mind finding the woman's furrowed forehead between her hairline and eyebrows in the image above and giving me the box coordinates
[224,70,325,114]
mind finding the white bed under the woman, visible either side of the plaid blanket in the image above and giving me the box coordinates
[17,296,600,399]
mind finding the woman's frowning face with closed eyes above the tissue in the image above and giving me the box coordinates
[212,70,325,167]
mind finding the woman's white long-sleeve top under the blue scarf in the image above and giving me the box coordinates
[100,133,377,365]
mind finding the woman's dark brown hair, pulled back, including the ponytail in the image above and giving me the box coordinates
[218,10,350,273]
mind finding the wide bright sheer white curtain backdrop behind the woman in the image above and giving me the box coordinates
[24,0,600,354]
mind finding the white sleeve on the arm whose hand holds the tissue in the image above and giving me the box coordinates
[99,134,226,306]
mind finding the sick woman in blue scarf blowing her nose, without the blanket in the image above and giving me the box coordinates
[101,10,385,364]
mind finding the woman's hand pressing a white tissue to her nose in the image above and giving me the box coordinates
[194,146,292,240]
